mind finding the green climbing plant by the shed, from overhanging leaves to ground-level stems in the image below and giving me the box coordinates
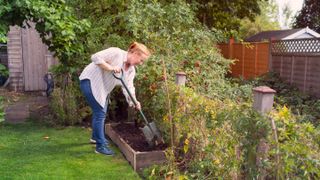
[0,0,90,124]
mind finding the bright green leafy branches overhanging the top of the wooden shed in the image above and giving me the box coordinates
[0,0,90,67]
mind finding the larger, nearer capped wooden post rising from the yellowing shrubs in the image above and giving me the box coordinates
[253,86,276,179]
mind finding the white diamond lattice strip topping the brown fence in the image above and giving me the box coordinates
[271,38,320,53]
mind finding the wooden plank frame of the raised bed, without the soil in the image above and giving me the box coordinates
[105,123,166,172]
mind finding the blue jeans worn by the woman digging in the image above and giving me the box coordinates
[80,79,109,146]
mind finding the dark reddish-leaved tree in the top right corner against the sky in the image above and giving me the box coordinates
[293,0,320,33]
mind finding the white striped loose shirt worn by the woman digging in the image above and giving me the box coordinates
[79,47,136,107]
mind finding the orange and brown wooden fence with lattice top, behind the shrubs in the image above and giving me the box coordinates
[218,38,320,97]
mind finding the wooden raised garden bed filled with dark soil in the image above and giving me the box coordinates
[106,123,167,171]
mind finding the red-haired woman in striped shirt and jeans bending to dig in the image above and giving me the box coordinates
[80,42,150,155]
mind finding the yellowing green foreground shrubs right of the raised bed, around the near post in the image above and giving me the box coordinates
[145,78,320,179]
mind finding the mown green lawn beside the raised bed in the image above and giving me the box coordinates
[0,121,140,180]
